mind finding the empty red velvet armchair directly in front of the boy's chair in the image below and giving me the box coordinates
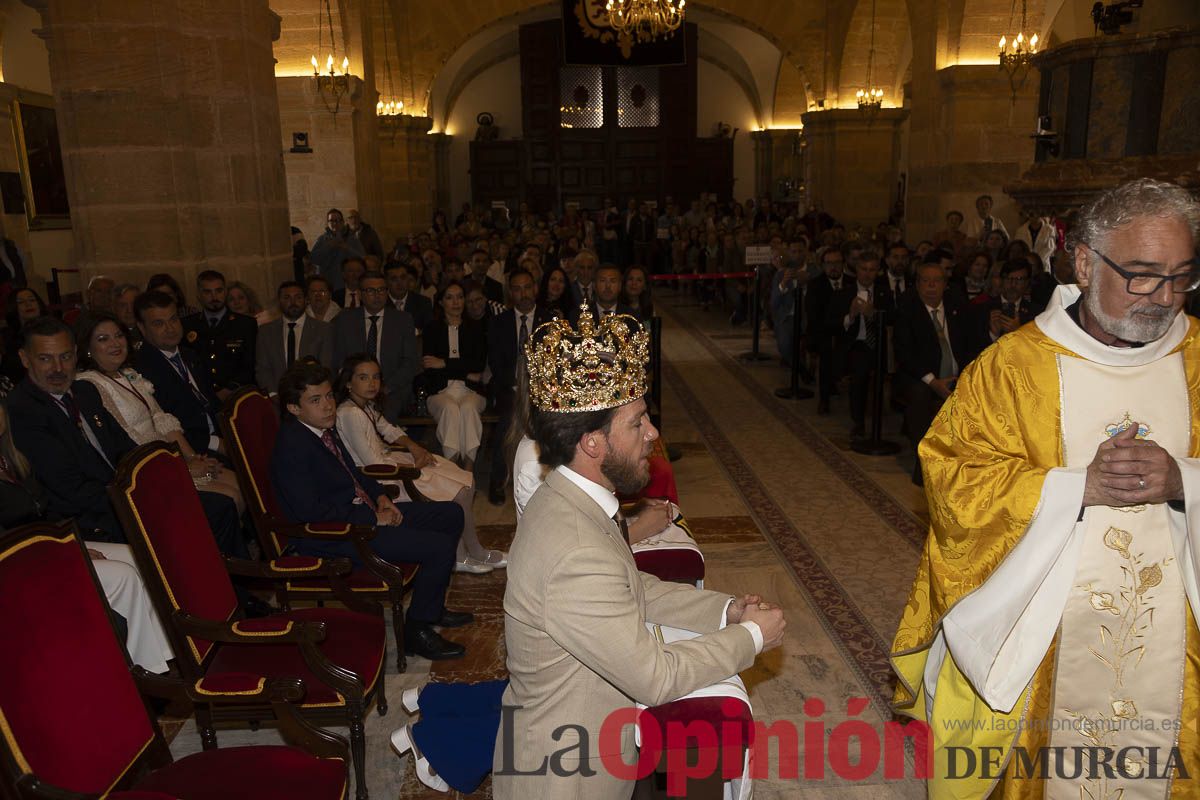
[109,443,388,800]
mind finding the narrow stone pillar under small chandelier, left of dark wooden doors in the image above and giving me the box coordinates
[379,114,437,237]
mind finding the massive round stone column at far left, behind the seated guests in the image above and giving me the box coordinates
[30,0,292,294]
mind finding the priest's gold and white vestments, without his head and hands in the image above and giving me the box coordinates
[892,289,1200,800]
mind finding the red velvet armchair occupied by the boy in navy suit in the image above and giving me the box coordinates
[221,386,421,672]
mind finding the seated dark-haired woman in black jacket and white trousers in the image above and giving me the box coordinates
[421,282,487,471]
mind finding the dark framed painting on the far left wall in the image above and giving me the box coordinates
[12,97,71,230]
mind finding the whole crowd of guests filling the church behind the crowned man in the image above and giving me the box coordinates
[0,190,1099,748]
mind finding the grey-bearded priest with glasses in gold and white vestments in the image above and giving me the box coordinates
[892,179,1200,800]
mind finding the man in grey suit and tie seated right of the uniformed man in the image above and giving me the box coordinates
[254,281,334,395]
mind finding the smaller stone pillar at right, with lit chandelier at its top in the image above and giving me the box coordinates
[802,108,908,228]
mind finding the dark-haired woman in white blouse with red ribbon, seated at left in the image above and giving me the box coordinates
[76,312,245,515]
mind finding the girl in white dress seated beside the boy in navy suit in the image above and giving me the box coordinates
[336,353,509,573]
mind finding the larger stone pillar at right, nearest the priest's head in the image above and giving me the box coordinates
[907,63,1039,241]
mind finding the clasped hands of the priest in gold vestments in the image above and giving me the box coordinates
[1084,422,1183,506]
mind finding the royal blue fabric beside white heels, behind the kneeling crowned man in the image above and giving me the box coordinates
[413,680,509,794]
